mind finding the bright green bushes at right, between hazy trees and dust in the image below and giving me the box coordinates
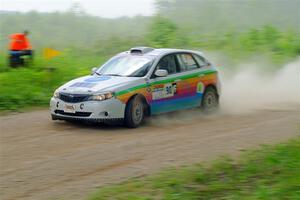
[190,25,300,63]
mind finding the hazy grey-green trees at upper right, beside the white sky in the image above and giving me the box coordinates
[156,0,300,35]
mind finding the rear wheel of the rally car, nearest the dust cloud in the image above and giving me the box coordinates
[201,87,219,113]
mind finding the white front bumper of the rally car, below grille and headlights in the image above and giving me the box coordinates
[50,97,126,122]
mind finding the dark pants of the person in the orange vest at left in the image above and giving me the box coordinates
[9,50,33,67]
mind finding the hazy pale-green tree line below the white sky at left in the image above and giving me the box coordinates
[0,11,150,53]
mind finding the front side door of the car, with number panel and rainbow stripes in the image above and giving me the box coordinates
[150,54,182,114]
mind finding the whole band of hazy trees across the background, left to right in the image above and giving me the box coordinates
[0,0,300,53]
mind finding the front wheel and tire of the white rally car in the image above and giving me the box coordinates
[125,95,145,128]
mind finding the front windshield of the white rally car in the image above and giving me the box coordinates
[97,55,153,77]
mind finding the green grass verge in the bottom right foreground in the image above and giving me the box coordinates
[88,138,300,200]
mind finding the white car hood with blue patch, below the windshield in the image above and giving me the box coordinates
[59,75,139,94]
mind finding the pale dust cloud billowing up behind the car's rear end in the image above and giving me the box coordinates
[220,58,300,114]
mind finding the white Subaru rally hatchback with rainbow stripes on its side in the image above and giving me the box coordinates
[50,47,220,128]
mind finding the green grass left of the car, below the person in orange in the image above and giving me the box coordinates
[0,52,104,111]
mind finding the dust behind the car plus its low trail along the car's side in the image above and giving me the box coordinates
[147,57,300,125]
